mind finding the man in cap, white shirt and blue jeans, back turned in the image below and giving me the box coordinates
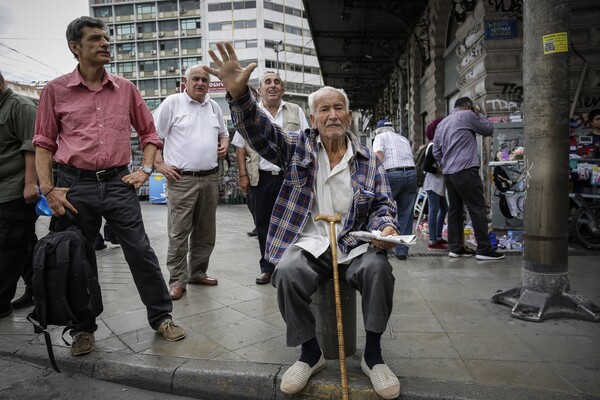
[373,119,418,260]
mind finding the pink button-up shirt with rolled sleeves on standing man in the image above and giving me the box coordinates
[33,68,163,171]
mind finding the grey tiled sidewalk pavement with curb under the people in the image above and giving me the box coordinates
[0,203,600,400]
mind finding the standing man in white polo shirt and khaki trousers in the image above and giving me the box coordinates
[154,65,229,300]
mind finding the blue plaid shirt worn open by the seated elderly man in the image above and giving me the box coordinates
[227,91,400,264]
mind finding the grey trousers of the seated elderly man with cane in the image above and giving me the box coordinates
[272,245,395,347]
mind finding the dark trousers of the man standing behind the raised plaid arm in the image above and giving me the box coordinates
[250,170,283,273]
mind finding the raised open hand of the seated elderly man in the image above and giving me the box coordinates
[203,42,256,99]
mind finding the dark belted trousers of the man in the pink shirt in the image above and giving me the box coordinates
[56,167,172,332]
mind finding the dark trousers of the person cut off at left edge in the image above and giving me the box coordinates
[0,198,37,312]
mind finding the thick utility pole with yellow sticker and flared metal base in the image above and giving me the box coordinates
[492,0,600,322]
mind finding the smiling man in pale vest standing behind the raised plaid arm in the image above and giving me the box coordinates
[231,71,310,285]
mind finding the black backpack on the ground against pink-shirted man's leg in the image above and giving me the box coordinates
[27,225,103,372]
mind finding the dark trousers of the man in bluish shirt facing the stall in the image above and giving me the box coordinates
[444,167,492,254]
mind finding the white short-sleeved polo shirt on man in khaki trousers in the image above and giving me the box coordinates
[153,92,229,171]
